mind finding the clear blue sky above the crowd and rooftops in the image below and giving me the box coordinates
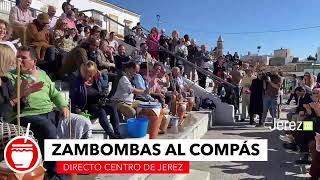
[107,0,320,58]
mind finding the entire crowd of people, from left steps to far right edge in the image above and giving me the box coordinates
[0,0,320,178]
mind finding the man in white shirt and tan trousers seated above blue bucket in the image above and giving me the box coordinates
[111,62,149,119]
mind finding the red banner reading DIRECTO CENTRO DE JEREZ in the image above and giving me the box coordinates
[57,161,190,174]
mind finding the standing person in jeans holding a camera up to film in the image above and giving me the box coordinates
[260,73,282,125]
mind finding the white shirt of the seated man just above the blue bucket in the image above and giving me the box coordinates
[111,76,134,104]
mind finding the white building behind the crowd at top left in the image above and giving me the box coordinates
[0,0,140,36]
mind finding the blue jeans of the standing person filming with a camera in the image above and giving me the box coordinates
[262,95,278,123]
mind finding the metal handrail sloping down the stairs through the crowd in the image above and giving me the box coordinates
[80,9,236,88]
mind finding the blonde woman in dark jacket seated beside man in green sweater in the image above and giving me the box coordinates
[70,61,121,139]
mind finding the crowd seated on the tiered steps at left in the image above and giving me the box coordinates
[0,0,200,179]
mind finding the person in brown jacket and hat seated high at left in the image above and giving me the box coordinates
[26,13,55,68]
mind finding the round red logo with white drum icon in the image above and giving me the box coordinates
[4,136,41,173]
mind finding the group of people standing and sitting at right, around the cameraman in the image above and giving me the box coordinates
[230,67,320,179]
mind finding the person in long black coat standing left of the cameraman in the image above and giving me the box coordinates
[249,72,264,125]
